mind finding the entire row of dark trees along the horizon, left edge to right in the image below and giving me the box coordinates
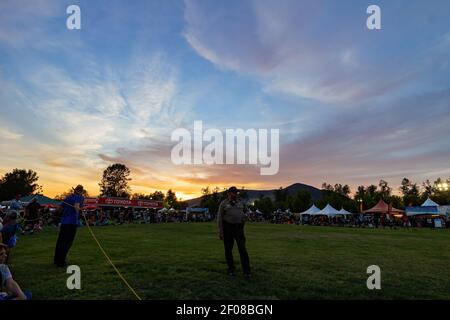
[0,163,450,214]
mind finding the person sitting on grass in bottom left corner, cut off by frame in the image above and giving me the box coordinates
[0,244,31,300]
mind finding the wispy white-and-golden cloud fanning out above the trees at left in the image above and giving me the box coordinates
[0,44,183,193]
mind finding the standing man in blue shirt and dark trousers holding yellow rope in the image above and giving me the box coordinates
[54,185,84,267]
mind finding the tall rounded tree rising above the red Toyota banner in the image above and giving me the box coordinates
[99,163,131,198]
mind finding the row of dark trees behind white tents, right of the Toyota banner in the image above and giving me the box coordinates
[201,178,450,214]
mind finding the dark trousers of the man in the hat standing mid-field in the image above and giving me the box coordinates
[223,221,250,273]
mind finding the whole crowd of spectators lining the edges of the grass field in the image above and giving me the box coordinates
[0,189,450,300]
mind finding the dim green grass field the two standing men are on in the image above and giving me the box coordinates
[10,223,450,299]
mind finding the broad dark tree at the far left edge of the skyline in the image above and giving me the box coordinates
[0,169,42,200]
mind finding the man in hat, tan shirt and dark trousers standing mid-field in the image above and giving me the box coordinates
[217,187,251,278]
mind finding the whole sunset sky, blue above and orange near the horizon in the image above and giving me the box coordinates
[0,0,450,199]
